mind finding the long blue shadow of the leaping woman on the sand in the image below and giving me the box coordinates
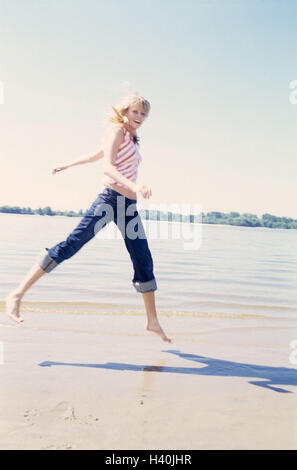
[39,349,297,393]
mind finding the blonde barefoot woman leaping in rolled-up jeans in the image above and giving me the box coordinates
[6,95,172,342]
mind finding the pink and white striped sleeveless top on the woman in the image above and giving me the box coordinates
[103,127,142,188]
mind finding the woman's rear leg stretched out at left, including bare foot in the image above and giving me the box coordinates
[5,194,113,323]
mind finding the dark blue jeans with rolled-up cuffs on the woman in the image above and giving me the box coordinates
[37,188,157,293]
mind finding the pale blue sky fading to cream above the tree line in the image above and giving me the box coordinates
[0,0,297,218]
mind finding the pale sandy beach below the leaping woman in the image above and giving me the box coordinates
[0,302,297,450]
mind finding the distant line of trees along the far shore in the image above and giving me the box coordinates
[0,206,297,229]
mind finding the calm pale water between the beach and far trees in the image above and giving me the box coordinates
[0,214,297,319]
